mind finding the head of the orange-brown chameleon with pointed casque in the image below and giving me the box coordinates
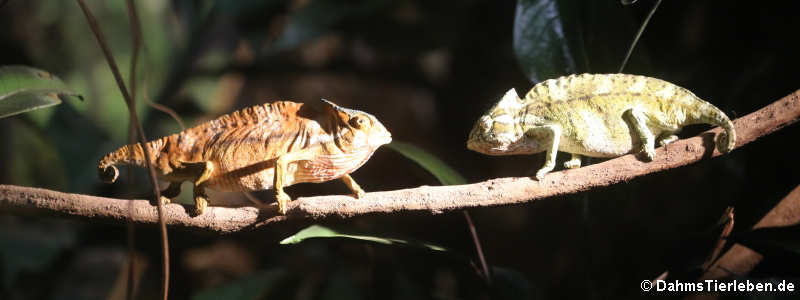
[322,99,392,149]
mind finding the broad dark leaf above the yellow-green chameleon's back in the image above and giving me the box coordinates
[513,0,647,83]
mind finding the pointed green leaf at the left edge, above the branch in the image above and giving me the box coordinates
[0,66,83,118]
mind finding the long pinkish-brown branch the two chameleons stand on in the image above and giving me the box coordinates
[0,90,800,233]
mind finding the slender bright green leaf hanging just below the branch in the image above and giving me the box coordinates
[281,225,449,251]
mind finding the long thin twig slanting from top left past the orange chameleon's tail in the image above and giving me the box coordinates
[76,0,169,300]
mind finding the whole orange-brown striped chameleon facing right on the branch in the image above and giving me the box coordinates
[97,99,392,214]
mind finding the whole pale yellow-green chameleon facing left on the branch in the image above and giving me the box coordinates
[467,74,736,180]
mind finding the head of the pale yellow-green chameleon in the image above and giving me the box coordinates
[467,88,526,155]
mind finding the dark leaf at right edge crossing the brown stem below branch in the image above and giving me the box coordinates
[728,225,800,256]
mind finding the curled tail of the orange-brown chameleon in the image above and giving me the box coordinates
[97,137,166,183]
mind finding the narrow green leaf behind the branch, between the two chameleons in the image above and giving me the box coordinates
[386,141,467,185]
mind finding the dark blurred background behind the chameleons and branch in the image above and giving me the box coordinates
[0,0,800,299]
